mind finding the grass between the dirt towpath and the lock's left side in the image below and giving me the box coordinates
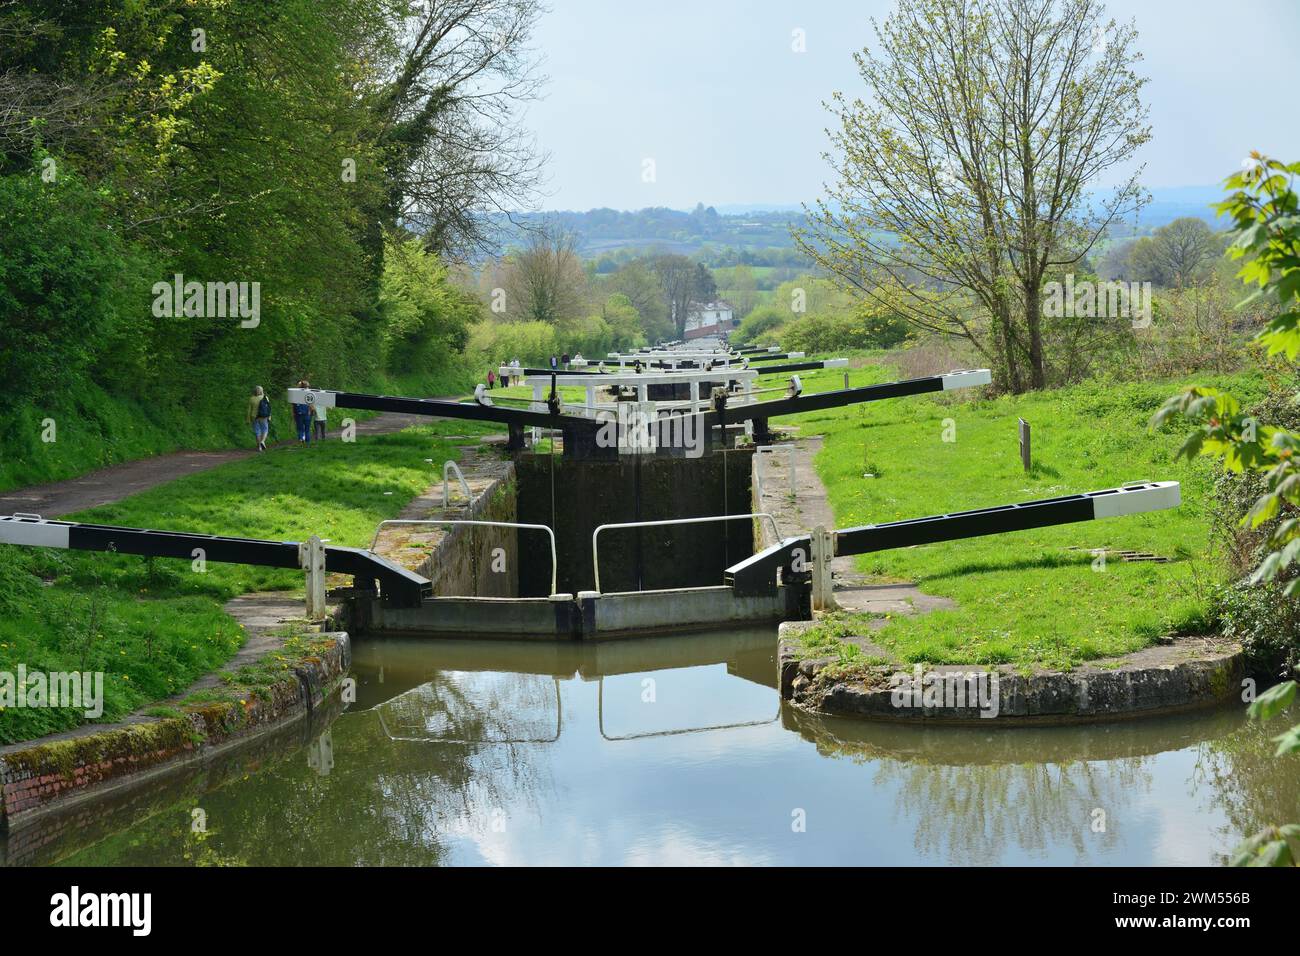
[0,421,493,743]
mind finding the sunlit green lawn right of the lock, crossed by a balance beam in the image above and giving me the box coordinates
[761,367,1264,667]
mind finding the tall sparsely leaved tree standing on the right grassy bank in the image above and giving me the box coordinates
[796,0,1151,392]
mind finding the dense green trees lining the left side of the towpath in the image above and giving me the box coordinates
[0,0,537,486]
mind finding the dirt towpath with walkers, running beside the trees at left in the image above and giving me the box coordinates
[0,412,429,518]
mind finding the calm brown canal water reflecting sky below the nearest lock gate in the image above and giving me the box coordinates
[9,630,1300,865]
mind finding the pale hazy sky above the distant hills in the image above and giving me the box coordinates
[527,0,1300,209]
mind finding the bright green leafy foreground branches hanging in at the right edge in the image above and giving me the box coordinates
[1152,153,1300,866]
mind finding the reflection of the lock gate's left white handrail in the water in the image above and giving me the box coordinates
[373,671,564,745]
